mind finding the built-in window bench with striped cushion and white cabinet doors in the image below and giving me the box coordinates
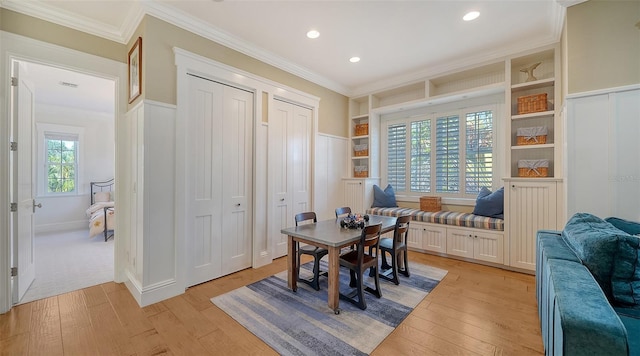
[366,208,505,267]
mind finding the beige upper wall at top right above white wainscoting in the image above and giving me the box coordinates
[566,0,640,94]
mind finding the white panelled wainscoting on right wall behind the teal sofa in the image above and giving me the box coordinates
[566,85,640,221]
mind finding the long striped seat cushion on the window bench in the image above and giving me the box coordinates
[366,208,504,231]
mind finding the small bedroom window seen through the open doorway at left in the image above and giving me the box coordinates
[44,132,78,194]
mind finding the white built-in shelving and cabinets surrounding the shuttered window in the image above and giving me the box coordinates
[343,44,564,271]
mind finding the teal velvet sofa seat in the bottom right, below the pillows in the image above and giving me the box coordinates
[547,259,629,355]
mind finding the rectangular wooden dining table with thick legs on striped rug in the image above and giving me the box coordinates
[281,215,396,314]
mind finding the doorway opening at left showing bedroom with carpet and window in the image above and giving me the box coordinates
[11,60,116,305]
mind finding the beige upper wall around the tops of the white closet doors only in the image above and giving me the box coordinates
[141,16,348,137]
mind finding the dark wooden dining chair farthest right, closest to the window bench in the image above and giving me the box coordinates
[379,215,411,285]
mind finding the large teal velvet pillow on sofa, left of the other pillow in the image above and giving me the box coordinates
[562,213,635,300]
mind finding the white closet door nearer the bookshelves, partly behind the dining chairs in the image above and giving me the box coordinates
[269,100,313,258]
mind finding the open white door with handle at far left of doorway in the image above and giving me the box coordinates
[11,62,36,304]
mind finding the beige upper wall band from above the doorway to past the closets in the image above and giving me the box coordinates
[0,8,349,137]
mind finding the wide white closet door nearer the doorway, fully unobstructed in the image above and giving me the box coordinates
[186,76,253,286]
